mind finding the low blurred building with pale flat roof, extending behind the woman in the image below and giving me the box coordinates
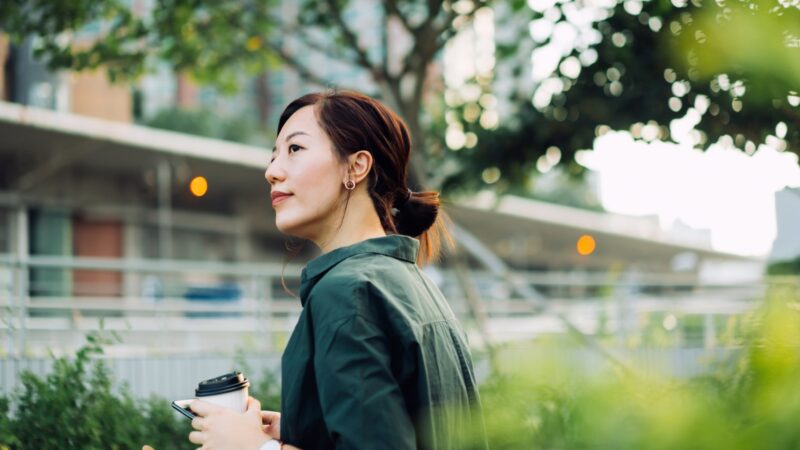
[0,103,761,353]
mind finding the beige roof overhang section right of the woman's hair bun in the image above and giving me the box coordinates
[448,196,763,271]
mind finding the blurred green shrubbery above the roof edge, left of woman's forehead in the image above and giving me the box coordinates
[143,108,266,144]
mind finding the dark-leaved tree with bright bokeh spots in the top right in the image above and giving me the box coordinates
[448,0,800,191]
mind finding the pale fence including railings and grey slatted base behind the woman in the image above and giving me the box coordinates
[0,255,766,396]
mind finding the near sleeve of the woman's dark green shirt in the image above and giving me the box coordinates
[314,314,416,450]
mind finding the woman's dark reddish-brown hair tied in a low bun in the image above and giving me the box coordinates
[278,90,451,264]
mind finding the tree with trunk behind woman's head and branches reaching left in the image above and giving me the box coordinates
[0,0,487,189]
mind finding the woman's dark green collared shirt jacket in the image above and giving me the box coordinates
[281,235,486,450]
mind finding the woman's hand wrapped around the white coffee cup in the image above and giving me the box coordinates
[189,397,272,450]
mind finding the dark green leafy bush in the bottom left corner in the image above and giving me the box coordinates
[0,333,194,450]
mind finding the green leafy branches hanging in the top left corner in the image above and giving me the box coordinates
[0,0,279,92]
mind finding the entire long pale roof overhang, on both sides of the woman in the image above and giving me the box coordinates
[0,102,761,268]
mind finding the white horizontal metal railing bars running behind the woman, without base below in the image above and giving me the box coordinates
[0,251,767,357]
